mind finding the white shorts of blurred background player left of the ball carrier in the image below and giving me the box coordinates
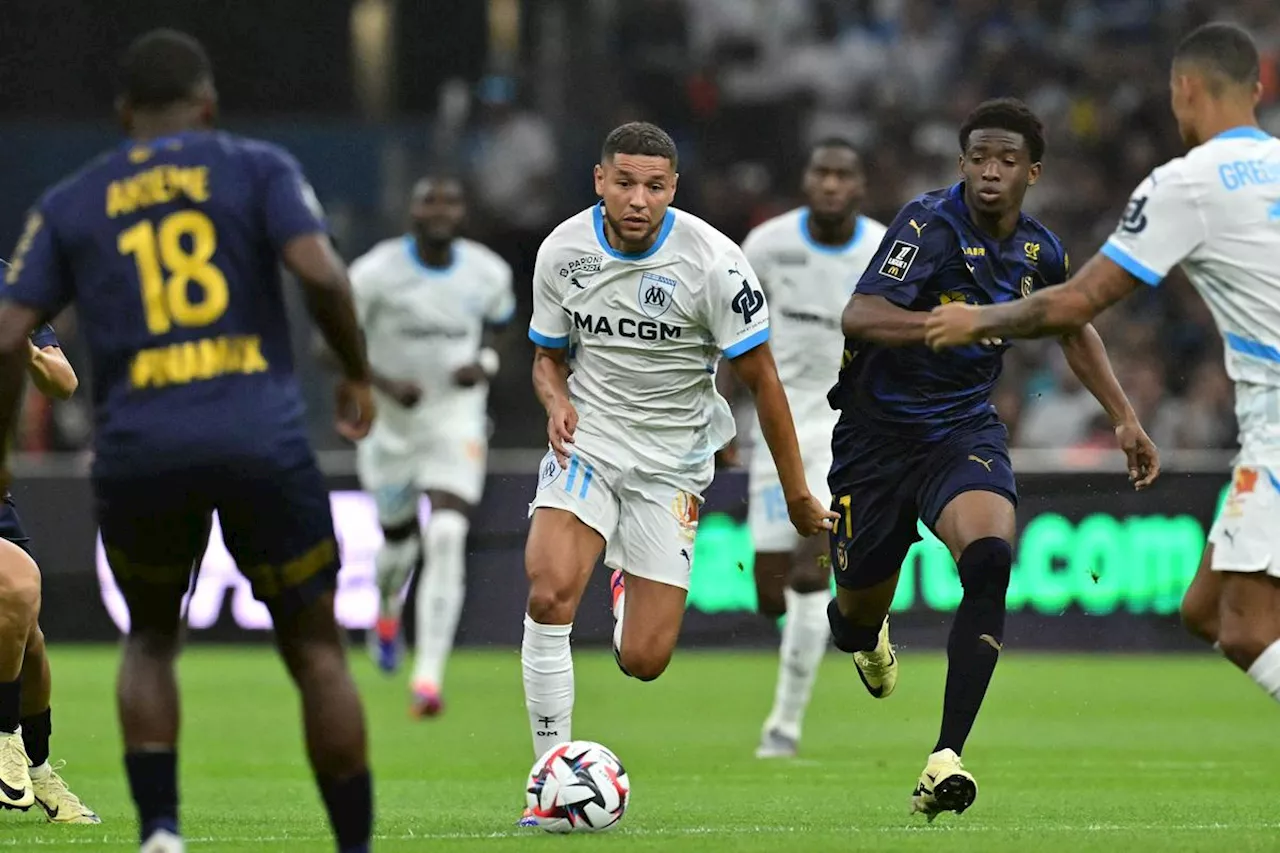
[356,420,488,525]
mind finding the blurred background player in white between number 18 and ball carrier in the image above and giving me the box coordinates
[351,177,516,717]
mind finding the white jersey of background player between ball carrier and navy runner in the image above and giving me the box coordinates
[742,207,884,421]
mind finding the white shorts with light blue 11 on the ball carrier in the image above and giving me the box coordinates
[529,451,713,589]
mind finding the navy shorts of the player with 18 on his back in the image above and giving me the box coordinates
[93,461,338,615]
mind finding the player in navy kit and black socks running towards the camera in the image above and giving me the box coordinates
[828,99,1157,820]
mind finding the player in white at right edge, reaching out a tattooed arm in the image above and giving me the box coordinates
[927,23,1280,701]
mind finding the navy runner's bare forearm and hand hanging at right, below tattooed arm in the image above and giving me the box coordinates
[1061,323,1160,489]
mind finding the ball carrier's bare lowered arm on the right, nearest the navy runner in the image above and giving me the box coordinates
[730,343,837,537]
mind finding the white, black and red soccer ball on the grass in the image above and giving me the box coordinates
[525,740,631,833]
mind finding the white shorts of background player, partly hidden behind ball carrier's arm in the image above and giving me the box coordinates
[746,418,831,553]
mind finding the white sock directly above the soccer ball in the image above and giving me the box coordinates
[520,615,573,757]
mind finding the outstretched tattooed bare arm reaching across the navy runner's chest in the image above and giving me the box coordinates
[925,255,1140,350]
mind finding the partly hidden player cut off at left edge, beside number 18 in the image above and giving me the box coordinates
[0,324,101,824]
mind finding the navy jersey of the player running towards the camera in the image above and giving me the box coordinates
[827,183,1069,441]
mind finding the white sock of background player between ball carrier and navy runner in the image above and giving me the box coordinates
[764,588,831,739]
